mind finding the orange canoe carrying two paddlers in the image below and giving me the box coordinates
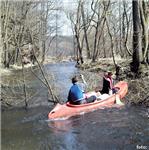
[48,81,128,120]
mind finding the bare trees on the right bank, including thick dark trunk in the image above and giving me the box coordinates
[68,0,149,72]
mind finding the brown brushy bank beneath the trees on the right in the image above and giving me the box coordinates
[77,59,149,107]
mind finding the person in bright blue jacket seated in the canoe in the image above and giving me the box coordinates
[68,75,96,105]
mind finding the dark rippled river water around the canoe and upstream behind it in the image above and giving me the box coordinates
[1,63,149,150]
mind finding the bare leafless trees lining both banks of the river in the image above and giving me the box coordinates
[1,0,149,72]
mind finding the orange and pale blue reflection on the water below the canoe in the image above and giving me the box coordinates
[48,116,87,150]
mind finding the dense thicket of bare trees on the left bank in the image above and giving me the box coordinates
[1,0,56,67]
